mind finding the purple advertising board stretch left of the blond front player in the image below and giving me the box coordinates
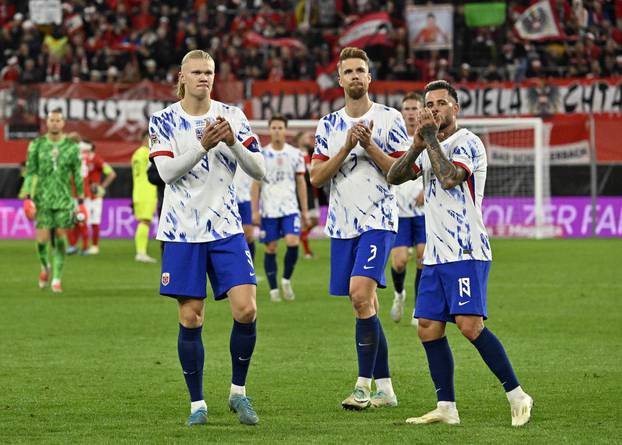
[0,198,158,239]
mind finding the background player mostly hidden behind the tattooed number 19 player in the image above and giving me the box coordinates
[391,92,425,326]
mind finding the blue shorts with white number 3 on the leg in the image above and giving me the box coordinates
[329,230,395,295]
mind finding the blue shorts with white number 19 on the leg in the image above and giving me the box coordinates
[415,260,490,322]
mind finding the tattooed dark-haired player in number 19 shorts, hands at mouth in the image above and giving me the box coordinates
[389,80,533,426]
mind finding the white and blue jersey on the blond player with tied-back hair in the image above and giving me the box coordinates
[149,100,261,243]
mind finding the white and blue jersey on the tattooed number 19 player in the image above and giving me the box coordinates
[414,128,492,265]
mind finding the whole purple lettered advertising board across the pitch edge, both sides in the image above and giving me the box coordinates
[0,196,622,239]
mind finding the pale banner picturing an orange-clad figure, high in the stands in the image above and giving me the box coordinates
[405,5,454,51]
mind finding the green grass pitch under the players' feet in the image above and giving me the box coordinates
[0,239,622,444]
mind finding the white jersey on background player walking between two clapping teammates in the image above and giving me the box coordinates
[259,144,305,218]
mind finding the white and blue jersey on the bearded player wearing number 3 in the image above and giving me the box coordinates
[313,103,409,239]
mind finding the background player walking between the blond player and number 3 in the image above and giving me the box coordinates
[251,115,309,302]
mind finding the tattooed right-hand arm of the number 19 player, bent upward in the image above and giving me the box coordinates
[419,109,468,190]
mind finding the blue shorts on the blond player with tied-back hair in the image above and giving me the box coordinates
[160,233,257,300]
